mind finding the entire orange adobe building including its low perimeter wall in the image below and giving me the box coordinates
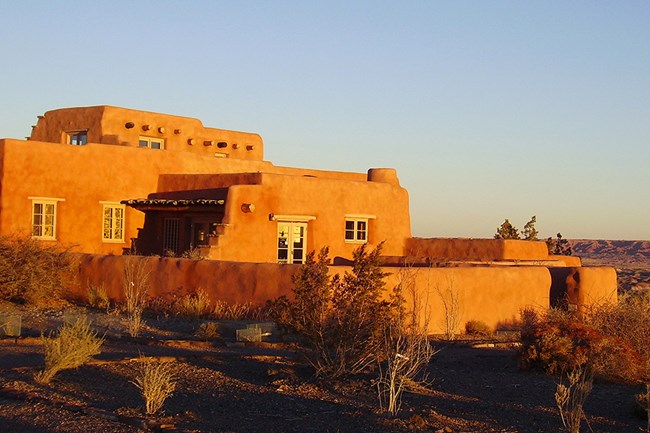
[0,106,616,332]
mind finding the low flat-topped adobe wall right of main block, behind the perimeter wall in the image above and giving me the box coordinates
[406,238,549,262]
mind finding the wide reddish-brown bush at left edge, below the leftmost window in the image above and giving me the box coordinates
[0,236,76,304]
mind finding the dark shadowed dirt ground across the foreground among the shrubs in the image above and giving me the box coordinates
[0,304,645,433]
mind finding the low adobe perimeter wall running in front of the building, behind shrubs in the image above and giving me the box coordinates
[72,254,616,334]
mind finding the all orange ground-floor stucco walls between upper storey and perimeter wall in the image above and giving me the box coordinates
[0,133,410,262]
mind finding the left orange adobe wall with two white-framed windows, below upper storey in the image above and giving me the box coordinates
[0,139,272,254]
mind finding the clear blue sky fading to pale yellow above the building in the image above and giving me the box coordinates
[0,0,650,239]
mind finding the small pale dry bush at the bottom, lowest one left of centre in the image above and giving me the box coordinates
[131,358,176,415]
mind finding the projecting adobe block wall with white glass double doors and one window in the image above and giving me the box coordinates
[211,173,411,262]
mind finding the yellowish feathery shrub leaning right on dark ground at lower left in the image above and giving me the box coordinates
[34,316,104,383]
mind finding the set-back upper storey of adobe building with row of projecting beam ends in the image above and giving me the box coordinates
[30,106,264,161]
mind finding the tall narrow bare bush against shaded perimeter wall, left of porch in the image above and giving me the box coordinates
[123,255,151,337]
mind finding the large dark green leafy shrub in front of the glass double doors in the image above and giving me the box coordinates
[271,244,391,377]
